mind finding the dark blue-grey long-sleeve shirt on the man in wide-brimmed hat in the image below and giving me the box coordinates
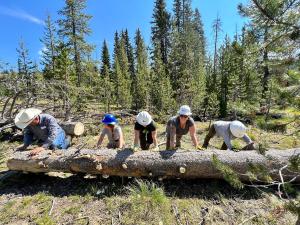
[24,114,64,148]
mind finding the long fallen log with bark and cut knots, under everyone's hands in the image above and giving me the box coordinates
[7,148,300,181]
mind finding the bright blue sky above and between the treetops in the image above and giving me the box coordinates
[0,0,247,69]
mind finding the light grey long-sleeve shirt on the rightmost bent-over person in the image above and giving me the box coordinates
[213,121,252,149]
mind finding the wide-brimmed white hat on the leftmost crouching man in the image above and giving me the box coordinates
[15,108,42,129]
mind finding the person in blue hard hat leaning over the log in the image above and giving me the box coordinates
[97,114,125,148]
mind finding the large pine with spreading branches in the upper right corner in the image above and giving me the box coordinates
[238,0,300,104]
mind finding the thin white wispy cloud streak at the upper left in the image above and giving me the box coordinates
[0,6,45,25]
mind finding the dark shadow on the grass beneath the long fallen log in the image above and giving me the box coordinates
[0,171,278,202]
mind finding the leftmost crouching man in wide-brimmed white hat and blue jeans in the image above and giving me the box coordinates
[15,108,70,155]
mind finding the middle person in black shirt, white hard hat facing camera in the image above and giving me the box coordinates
[133,111,159,151]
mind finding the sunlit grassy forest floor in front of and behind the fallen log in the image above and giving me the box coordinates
[0,106,300,225]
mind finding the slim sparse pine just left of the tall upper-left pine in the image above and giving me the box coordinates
[41,15,58,79]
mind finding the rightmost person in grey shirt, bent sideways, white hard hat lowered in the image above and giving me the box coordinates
[202,120,254,150]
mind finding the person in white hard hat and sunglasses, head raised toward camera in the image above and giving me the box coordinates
[166,105,202,150]
